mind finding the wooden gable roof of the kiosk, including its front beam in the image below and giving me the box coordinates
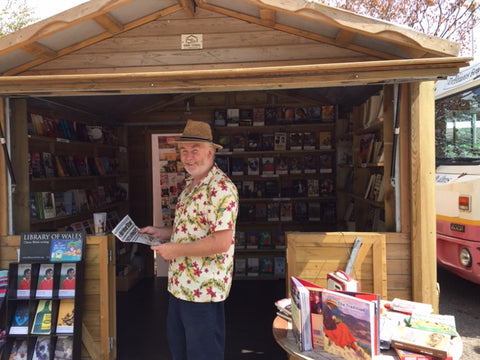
[0,0,468,95]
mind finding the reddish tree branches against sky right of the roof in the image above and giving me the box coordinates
[321,0,480,53]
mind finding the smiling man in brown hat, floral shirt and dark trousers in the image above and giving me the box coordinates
[140,120,238,360]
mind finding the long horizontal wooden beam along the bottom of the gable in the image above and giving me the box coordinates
[0,58,467,95]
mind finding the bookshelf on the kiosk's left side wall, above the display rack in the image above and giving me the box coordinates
[27,107,128,234]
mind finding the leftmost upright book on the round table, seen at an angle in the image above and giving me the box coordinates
[290,276,313,351]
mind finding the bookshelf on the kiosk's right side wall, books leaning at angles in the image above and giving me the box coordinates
[337,91,388,231]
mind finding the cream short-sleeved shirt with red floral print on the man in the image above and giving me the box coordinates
[168,165,238,302]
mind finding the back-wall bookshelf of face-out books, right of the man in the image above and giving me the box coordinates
[213,105,337,279]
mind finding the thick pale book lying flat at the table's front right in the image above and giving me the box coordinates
[390,325,451,359]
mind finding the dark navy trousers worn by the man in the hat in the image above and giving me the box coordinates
[167,294,225,360]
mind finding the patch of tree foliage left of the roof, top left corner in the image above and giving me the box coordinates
[0,0,38,36]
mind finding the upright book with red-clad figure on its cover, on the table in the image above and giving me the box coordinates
[322,289,378,360]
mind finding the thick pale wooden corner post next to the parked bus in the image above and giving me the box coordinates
[410,81,438,312]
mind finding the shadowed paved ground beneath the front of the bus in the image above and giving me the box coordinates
[437,268,480,360]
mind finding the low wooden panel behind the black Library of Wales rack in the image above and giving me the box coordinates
[0,235,116,360]
